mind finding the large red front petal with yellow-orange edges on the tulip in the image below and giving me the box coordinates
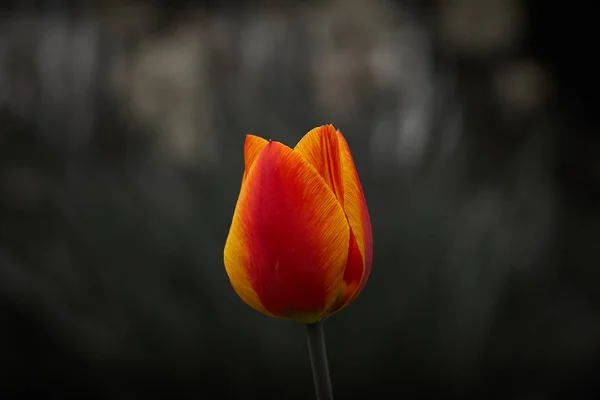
[224,142,350,323]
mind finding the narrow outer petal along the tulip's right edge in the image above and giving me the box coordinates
[332,127,373,312]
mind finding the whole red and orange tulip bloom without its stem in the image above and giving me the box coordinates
[224,125,373,324]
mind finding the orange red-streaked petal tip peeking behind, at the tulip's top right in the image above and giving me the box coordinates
[294,125,344,204]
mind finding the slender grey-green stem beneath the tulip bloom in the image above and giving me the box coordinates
[306,321,333,400]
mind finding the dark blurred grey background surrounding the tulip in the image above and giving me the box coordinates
[0,0,600,400]
